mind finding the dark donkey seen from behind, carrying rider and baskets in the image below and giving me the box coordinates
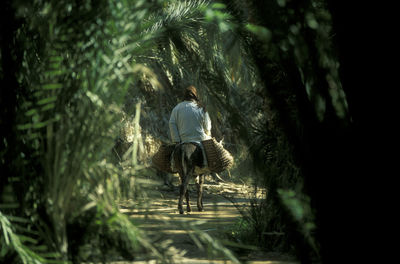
[173,143,204,214]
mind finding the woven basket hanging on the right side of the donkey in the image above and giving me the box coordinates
[201,138,233,173]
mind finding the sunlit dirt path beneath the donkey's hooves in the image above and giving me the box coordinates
[124,175,296,264]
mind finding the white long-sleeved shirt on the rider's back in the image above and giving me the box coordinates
[169,101,211,143]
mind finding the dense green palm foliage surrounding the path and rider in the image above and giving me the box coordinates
[0,0,351,263]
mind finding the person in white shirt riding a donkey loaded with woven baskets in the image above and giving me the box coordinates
[151,85,234,214]
